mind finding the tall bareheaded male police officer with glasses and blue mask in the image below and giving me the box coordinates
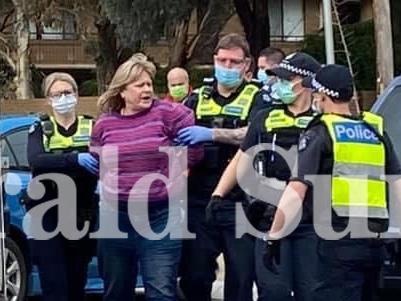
[179,34,266,301]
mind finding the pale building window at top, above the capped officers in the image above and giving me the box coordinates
[268,0,304,41]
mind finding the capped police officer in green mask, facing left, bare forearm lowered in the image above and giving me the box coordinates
[212,52,320,301]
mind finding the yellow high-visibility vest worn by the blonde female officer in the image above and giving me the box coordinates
[43,116,92,152]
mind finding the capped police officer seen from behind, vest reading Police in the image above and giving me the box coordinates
[270,65,401,301]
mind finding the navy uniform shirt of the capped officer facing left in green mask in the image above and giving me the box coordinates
[240,105,313,181]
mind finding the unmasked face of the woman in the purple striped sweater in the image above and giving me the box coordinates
[120,71,153,112]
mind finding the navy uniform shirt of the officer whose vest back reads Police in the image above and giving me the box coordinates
[291,116,401,224]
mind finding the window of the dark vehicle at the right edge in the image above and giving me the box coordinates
[378,86,401,160]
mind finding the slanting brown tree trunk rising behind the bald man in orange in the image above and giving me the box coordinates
[188,0,233,65]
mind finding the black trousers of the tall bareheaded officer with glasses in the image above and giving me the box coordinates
[180,202,255,301]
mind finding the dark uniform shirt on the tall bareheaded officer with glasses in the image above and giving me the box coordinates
[185,81,270,121]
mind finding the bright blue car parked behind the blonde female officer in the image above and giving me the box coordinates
[0,115,143,301]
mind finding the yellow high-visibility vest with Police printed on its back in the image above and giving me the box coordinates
[321,112,388,219]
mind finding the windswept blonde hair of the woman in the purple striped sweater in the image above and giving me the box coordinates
[97,53,156,113]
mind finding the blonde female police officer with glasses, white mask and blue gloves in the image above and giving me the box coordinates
[26,73,98,301]
